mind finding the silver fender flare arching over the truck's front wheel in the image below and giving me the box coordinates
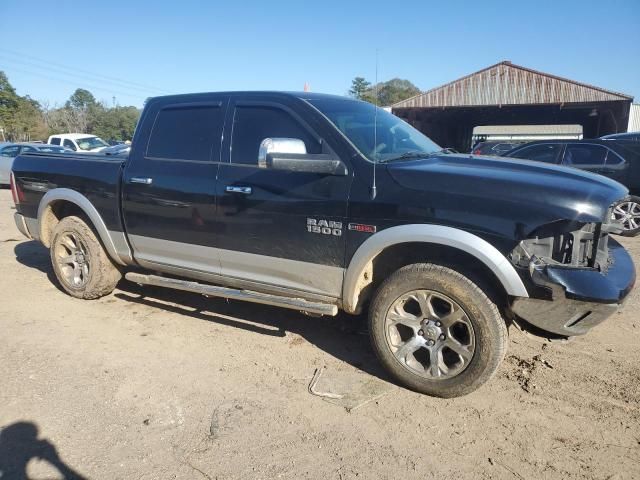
[342,224,529,313]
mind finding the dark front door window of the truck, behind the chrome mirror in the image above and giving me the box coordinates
[231,106,322,166]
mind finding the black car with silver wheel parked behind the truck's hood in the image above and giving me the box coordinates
[504,139,640,236]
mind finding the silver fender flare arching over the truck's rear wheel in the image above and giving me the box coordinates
[36,188,133,265]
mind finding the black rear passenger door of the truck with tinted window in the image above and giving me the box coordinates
[122,96,228,273]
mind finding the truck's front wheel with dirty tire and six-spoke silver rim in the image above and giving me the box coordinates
[369,263,507,397]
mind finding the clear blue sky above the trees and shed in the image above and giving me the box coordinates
[0,0,640,106]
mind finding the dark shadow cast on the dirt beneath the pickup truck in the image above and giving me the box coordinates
[14,241,395,383]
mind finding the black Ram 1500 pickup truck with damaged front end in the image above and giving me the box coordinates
[11,92,635,396]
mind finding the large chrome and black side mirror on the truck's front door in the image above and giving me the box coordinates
[258,138,349,176]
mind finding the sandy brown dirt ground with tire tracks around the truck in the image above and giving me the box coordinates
[0,190,640,480]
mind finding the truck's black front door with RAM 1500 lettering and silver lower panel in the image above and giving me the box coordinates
[217,101,352,298]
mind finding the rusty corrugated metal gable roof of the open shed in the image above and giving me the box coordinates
[392,61,633,109]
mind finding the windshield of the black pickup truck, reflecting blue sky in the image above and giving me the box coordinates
[308,99,442,162]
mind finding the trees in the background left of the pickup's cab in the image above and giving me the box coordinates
[0,71,140,142]
